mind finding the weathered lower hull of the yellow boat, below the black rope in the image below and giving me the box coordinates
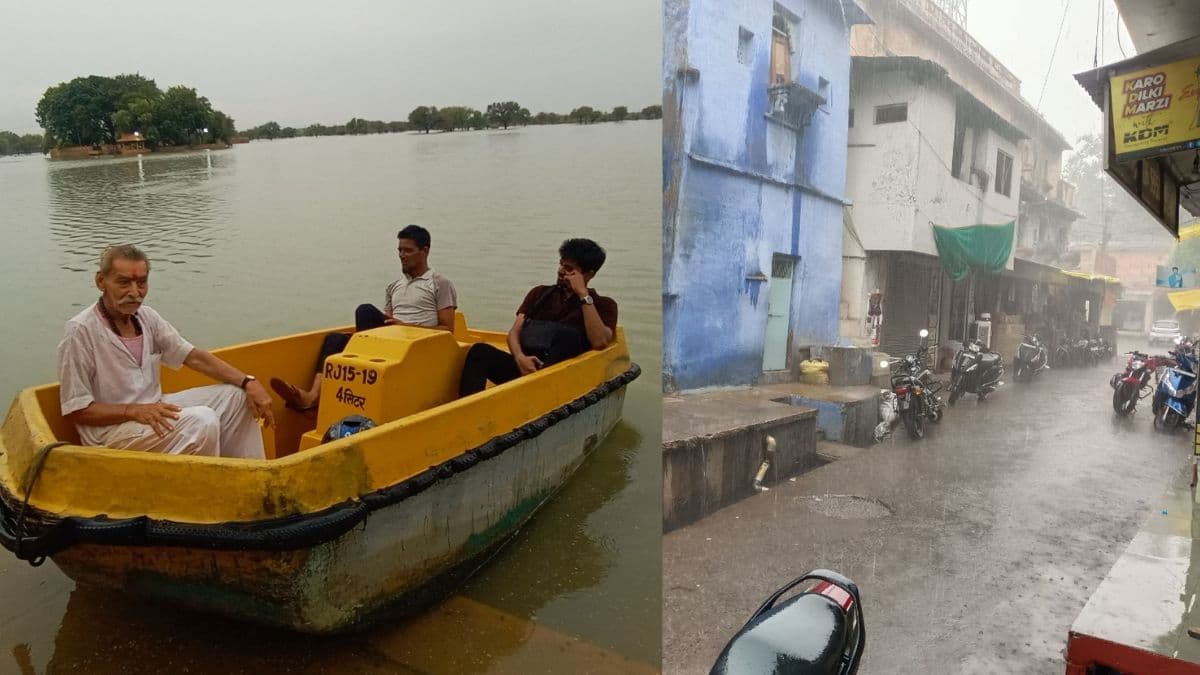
[52,387,625,633]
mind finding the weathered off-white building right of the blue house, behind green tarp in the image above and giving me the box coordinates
[841,0,1082,353]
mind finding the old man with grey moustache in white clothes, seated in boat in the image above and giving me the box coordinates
[59,245,274,459]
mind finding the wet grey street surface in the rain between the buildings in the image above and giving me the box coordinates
[662,339,1190,675]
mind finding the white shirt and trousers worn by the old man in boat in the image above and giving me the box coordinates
[59,305,265,459]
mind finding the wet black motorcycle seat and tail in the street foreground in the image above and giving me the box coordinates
[709,569,866,675]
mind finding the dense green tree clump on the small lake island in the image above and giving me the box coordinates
[35,74,236,147]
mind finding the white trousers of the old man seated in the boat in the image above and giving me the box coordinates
[79,384,266,459]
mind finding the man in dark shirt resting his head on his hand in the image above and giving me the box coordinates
[458,239,617,396]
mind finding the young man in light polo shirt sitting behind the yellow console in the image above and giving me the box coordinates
[271,225,458,412]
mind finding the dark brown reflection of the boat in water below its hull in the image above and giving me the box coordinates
[25,423,656,675]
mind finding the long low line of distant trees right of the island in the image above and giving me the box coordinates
[241,101,662,141]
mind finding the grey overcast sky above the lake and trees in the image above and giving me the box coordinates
[0,0,662,133]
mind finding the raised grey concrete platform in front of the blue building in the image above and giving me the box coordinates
[662,388,822,532]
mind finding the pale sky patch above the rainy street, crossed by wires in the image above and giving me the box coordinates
[967,0,1135,144]
